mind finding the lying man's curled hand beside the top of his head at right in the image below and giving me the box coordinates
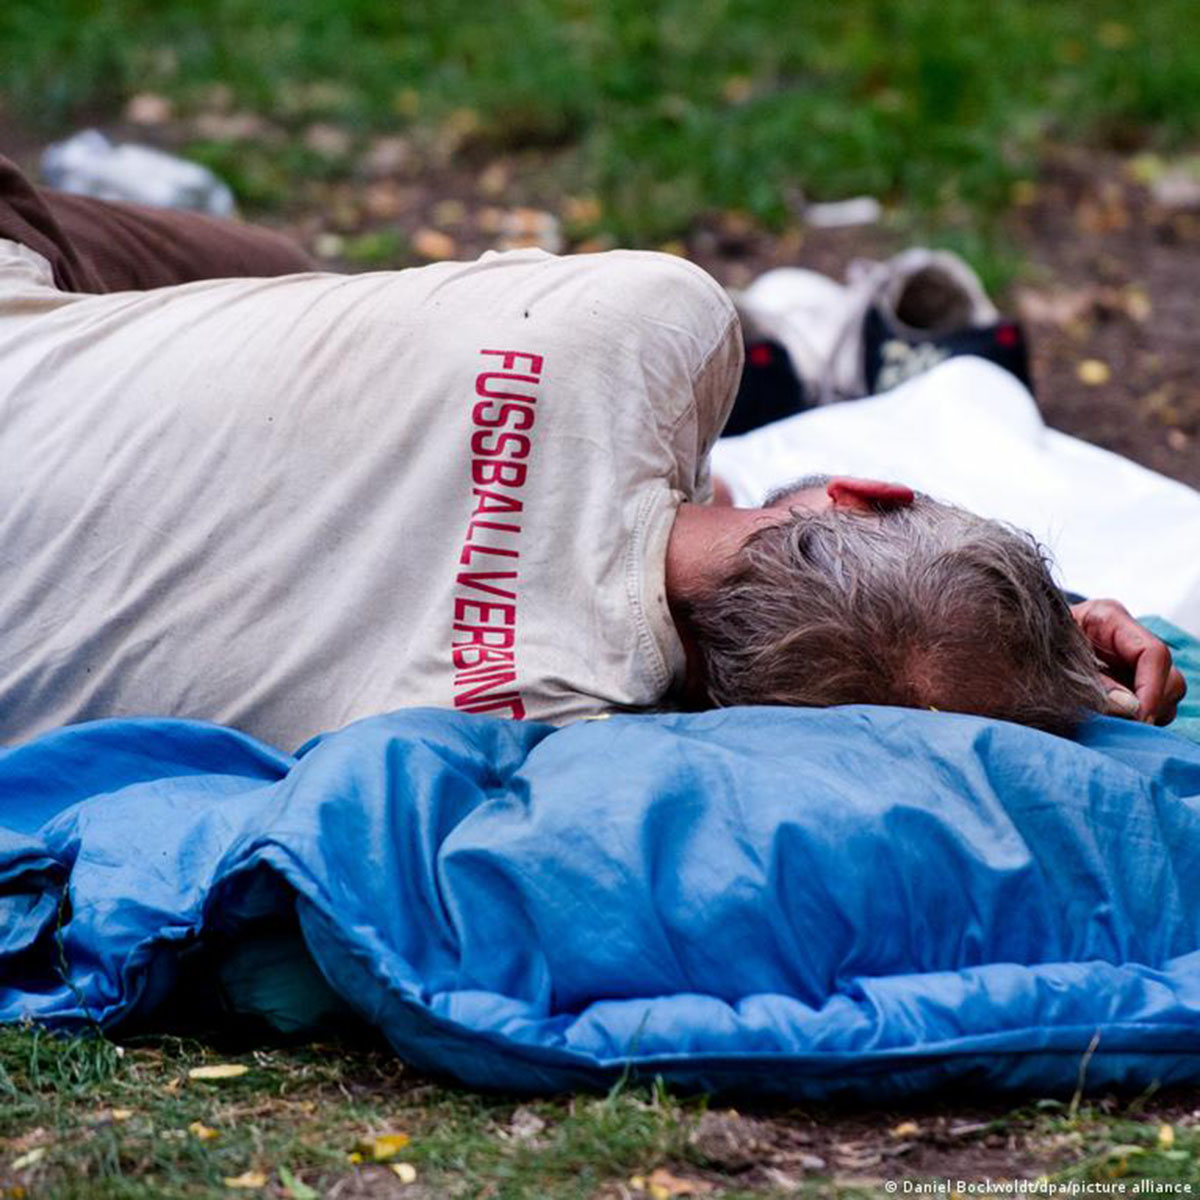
[1070,600,1188,725]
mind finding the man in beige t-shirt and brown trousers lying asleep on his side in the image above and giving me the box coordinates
[0,152,1183,748]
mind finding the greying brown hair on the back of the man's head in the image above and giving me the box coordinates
[688,488,1104,733]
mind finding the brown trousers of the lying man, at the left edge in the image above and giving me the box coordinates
[0,155,314,292]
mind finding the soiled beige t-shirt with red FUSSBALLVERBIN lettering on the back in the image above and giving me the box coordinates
[0,242,740,749]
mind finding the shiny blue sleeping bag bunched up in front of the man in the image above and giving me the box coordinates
[0,628,1200,1099]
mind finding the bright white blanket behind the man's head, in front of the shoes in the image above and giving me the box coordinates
[713,358,1200,635]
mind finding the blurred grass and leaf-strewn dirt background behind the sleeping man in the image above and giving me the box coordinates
[0,0,1200,485]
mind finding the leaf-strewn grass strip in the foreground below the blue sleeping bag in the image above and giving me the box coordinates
[0,1028,1200,1200]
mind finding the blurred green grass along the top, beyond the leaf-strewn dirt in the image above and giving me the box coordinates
[0,0,1200,244]
